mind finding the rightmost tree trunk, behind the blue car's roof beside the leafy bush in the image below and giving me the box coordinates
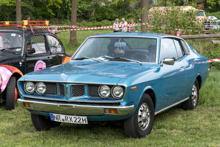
[141,0,148,32]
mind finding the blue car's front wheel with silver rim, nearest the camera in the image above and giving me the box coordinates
[124,94,154,138]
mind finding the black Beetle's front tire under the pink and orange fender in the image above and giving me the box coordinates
[5,76,16,110]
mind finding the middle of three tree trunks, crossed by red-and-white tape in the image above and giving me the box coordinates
[70,0,77,45]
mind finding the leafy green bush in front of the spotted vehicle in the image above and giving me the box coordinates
[149,7,203,34]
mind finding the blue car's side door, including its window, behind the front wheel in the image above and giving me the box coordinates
[158,38,186,109]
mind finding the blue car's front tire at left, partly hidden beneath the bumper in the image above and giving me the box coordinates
[31,114,61,131]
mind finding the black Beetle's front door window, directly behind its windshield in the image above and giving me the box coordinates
[26,35,47,55]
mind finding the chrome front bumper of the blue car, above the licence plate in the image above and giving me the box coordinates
[18,99,134,116]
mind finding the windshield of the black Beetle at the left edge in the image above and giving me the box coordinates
[0,32,22,54]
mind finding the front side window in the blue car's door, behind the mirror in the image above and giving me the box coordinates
[160,38,177,61]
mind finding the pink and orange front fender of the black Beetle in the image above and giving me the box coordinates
[0,65,23,92]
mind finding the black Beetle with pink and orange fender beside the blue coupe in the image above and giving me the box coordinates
[0,27,70,110]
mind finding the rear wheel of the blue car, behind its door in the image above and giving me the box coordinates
[182,80,199,110]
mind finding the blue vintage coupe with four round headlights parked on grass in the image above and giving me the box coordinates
[18,33,209,138]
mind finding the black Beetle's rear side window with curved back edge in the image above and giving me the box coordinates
[47,36,63,53]
